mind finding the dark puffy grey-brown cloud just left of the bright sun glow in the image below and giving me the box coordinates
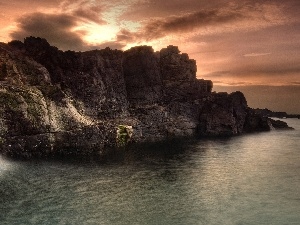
[11,13,85,50]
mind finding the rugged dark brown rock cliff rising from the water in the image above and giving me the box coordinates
[0,37,282,157]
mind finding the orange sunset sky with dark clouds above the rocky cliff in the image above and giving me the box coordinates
[0,0,300,113]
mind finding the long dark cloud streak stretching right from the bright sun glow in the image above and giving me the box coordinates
[118,2,289,44]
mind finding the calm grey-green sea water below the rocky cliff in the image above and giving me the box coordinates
[0,119,300,225]
